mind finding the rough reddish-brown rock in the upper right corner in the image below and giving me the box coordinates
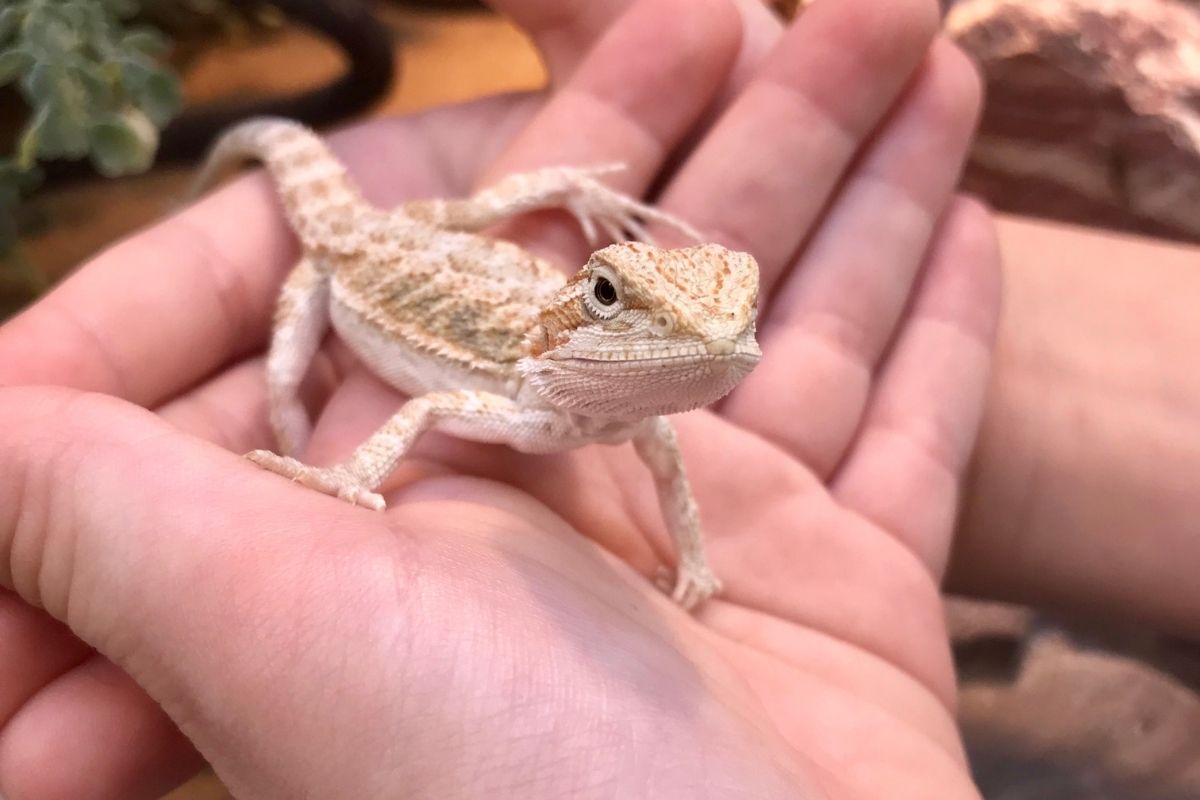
[947,0,1200,241]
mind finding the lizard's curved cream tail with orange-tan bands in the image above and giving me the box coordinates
[187,116,366,249]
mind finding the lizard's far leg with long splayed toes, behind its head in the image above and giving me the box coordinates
[400,164,701,245]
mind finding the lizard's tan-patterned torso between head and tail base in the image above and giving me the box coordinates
[325,219,565,396]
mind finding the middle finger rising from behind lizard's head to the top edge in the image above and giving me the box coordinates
[662,0,937,291]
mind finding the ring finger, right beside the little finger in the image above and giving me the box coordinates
[722,40,979,476]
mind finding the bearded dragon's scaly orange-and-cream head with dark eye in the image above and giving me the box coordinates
[520,242,762,420]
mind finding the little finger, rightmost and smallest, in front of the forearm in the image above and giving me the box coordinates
[832,200,1000,578]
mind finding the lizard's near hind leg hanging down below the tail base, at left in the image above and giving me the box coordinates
[266,255,329,455]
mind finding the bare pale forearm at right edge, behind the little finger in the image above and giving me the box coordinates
[949,218,1200,639]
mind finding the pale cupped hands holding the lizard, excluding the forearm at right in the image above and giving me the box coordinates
[0,0,998,800]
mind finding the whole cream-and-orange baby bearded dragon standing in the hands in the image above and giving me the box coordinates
[197,119,761,608]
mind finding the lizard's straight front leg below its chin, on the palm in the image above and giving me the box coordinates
[634,416,721,609]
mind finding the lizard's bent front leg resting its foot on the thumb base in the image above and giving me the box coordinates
[246,390,578,511]
